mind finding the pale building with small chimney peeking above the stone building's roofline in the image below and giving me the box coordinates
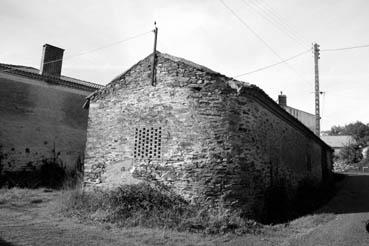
[278,92,316,132]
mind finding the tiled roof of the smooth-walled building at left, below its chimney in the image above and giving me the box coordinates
[0,63,104,92]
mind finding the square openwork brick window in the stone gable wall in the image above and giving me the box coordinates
[133,127,161,159]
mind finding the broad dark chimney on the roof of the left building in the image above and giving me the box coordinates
[40,44,64,77]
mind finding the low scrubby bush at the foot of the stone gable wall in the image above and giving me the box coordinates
[62,183,260,234]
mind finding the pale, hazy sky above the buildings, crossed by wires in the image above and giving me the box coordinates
[0,0,369,130]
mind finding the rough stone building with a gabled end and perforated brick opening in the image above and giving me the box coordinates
[84,52,332,219]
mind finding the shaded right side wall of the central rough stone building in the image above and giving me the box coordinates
[226,92,326,216]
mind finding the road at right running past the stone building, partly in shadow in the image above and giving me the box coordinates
[284,174,369,246]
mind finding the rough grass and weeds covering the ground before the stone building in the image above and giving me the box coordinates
[0,186,335,246]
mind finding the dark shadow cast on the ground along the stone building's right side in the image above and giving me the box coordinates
[258,173,369,224]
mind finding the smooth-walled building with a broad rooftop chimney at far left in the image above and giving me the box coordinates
[0,44,102,179]
